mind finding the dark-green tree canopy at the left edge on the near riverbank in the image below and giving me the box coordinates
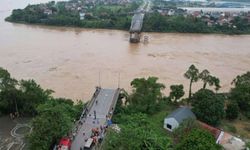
[0,68,53,116]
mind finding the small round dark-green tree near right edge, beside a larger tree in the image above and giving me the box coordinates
[226,102,239,120]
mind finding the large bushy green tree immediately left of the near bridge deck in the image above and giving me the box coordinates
[28,100,76,150]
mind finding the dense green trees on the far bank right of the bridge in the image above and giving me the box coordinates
[143,13,250,34]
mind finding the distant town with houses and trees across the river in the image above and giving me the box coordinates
[6,0,250,34]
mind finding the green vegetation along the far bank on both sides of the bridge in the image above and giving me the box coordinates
[6,1,250,34]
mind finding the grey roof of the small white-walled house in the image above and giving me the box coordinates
[167,107,196,124]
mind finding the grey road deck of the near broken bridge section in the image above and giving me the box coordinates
[71,89,119,150]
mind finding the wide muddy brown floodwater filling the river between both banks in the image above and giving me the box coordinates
[0,0,250,100]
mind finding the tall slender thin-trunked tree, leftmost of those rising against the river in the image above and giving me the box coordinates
[184,64,199,99]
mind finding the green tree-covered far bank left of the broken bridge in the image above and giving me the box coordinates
[6,2,139,29]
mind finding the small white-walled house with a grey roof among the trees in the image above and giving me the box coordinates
[163,107,196,132]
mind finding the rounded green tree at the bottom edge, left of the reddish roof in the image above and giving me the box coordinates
[175,129,222,150]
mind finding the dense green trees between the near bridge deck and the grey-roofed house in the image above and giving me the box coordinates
[104,77,171,150]
